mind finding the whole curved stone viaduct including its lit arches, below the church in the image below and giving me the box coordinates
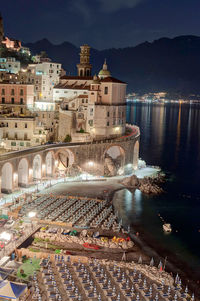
[0,126,140,193]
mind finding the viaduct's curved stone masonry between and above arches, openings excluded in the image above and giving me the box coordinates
[0,127,140,191]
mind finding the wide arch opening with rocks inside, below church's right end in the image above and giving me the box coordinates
[104,145,125,176]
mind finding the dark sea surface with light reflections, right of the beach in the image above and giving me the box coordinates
[114,103,200,283]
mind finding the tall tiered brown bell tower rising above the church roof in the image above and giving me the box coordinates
[77,45,92,76]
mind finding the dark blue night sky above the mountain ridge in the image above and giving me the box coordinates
[0,0,200,49]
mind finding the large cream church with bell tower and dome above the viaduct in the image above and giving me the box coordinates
[53,45,126,141]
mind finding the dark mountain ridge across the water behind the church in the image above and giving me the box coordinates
[26,36,200,94]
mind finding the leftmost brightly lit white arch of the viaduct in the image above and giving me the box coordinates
[1,162,13,193]
